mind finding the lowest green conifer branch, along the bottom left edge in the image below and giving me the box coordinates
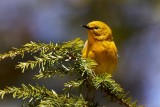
[0,84,87,107]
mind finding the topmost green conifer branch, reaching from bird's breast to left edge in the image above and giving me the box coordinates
[0,38,83,60]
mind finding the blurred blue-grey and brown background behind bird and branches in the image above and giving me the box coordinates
[0,0,160,107]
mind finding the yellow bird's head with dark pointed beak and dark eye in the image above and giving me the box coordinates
[83,21,113,40]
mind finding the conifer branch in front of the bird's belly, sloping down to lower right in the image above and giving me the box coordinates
[65,59,143,107]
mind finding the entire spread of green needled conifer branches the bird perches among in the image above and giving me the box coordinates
[0,38,141,107]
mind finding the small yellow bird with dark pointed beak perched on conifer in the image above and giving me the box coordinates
[82,21,118,74]
